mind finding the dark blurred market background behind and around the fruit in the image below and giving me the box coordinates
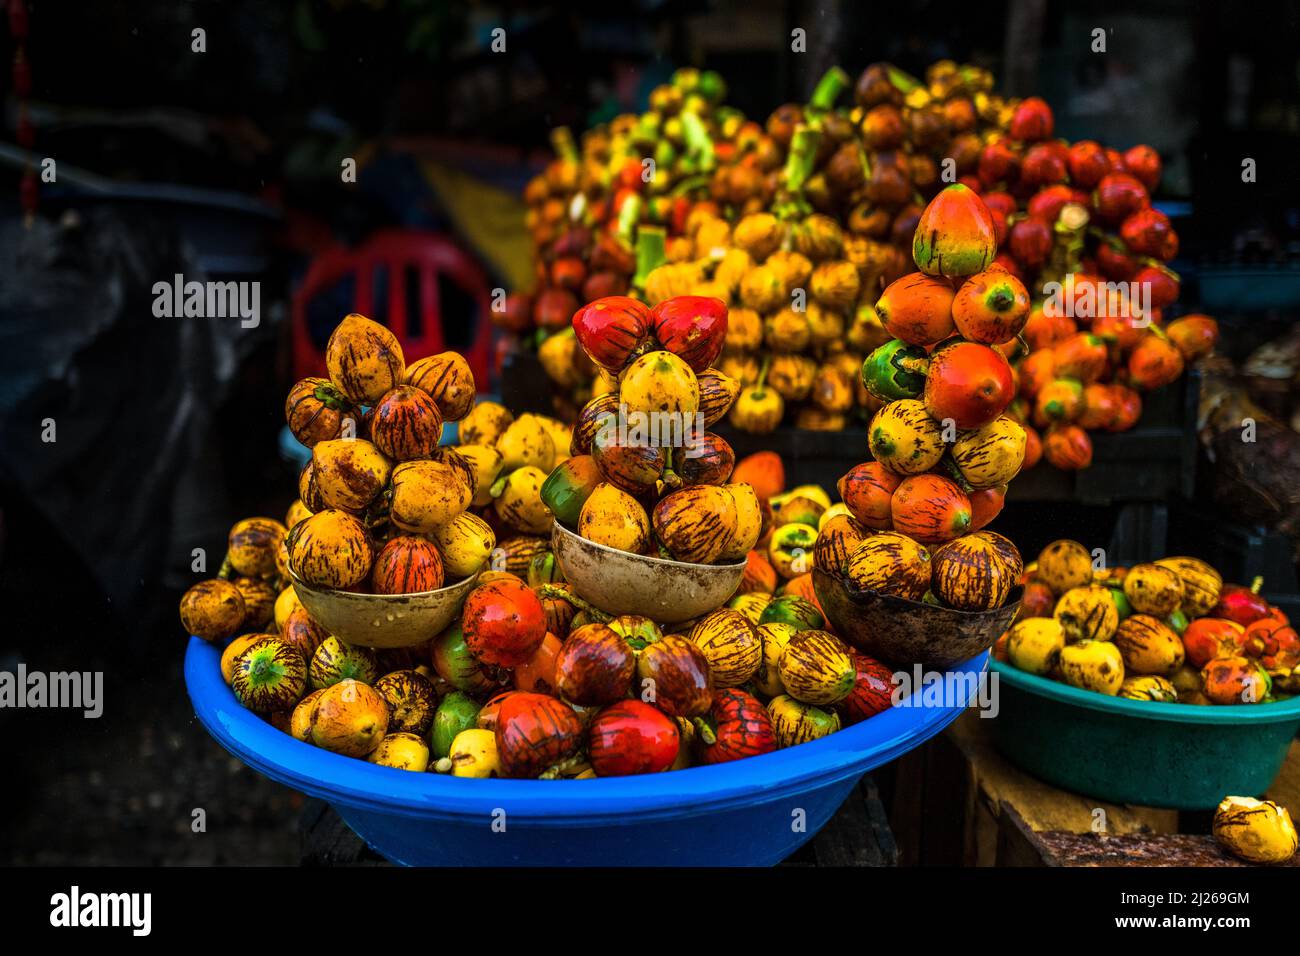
[0,0,1300,864]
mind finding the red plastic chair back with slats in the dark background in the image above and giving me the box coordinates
[293,229,491,389]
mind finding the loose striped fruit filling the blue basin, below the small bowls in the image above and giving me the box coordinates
[189,538,894,779]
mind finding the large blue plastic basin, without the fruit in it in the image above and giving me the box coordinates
[185,637,988,866]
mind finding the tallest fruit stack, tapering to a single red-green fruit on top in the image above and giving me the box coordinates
[815,185,1030,611]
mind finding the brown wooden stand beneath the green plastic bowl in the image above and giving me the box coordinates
[887,710,1300,866]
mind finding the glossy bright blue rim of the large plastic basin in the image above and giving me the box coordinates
[185,637,988,826]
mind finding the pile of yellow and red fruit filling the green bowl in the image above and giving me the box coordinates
[993,540,1300,704]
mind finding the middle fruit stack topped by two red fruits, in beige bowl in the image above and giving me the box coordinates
[541,295,763,564]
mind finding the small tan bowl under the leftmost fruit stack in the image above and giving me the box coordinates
[289,570,478,648]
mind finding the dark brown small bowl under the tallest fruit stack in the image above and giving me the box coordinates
[813,568,1021,670]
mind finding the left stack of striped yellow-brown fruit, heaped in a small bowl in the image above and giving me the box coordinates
[285,315,494,594]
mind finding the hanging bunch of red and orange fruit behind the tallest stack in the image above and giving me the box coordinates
[941,98,1218,471]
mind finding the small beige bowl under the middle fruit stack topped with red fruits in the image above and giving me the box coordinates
[551,522,745,624]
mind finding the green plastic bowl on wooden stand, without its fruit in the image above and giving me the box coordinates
[989,661,1300,810]
